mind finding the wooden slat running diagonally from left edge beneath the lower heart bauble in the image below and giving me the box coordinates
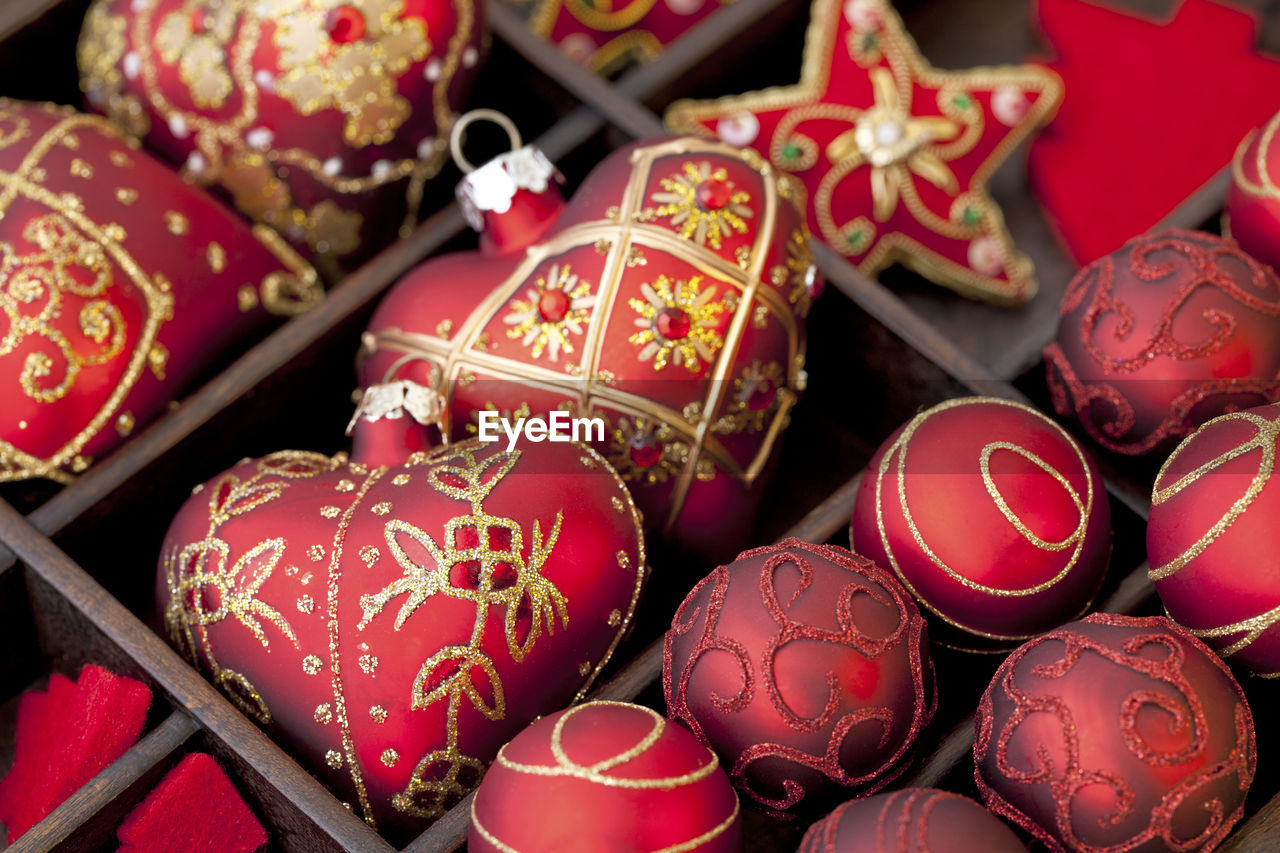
[0,501,392,852]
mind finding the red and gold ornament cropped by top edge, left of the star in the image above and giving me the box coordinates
[530,0,733,74]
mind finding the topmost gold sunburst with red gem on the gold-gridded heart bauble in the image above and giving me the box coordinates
[636,160,755,248]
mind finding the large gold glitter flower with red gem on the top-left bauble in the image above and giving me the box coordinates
[264,0,431,147]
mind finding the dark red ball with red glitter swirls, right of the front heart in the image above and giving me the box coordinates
[662,539,934,811]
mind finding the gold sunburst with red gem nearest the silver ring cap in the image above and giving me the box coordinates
[503,264,595,361]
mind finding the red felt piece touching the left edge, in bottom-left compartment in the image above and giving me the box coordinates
[0,665,151,841]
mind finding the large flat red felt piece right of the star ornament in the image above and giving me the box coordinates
[1028,0,1280,264]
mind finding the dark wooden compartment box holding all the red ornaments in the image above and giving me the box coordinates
[0,0,1280,853]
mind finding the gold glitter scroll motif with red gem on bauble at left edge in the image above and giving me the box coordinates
[0,214,133,403]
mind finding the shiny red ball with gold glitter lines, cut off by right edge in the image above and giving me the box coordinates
[1147,405,1280,676]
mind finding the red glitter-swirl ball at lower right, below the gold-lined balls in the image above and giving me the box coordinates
[973,613,1257,853]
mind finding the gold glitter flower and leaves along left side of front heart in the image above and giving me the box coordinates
[163,451,344,724]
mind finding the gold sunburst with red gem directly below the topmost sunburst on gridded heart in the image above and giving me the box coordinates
[627,275,727,373]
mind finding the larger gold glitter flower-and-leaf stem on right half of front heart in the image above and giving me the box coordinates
[357,446,568,818]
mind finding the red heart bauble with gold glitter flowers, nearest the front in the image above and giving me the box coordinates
[156,441,645,838]
